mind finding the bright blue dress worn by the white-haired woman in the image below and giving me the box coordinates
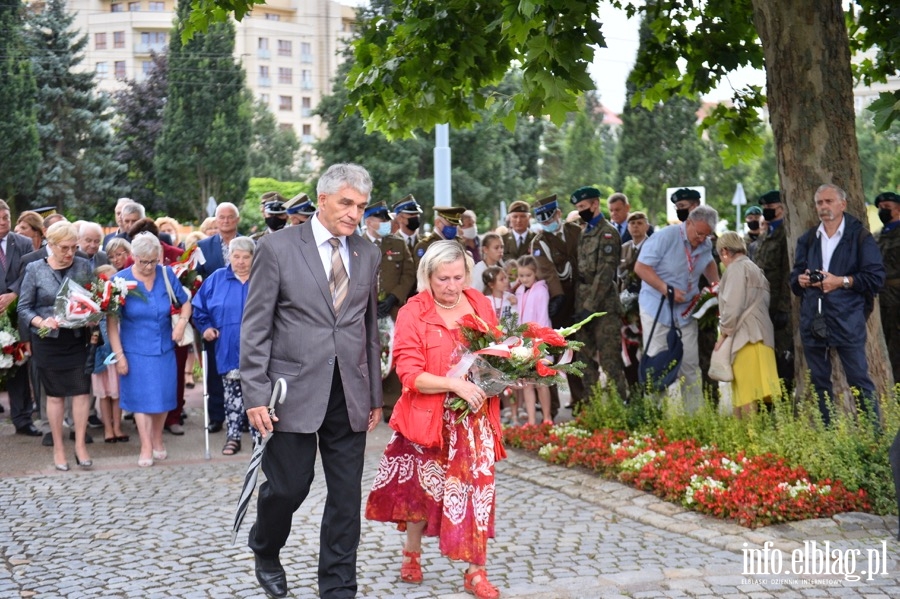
[118,265,188,414]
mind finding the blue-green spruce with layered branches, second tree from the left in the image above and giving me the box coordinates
[28,0,125,218]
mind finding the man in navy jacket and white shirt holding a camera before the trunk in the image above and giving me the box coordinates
[791,183,885,425]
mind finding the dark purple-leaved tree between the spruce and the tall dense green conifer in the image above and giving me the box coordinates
[115,54,174,214]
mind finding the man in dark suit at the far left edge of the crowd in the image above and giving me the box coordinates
[0,200,41,437]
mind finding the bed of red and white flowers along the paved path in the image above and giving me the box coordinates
[504,423,869,528]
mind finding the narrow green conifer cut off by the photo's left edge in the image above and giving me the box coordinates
[0,0,41,211]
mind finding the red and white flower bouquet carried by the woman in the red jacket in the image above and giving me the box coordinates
[447,312,604,421]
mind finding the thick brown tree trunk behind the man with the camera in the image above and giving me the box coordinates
[752,0,893,408]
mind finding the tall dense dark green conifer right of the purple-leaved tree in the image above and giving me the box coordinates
[154,0,252,218]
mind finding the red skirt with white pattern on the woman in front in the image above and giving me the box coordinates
[366,409,496,566]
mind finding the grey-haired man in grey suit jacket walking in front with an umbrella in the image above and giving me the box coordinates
[241,164,382,599]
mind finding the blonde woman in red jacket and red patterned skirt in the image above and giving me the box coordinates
[366,241,505,599]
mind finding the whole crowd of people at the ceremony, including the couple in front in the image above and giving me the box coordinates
[0,169,900,599]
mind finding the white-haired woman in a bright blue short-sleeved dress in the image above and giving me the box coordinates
[108,233,191,467]
